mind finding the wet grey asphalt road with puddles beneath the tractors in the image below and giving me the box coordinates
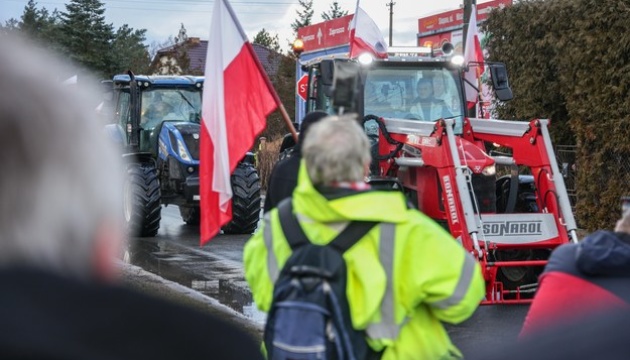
[130,206,528,355]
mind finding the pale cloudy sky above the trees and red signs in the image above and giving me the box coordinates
[0,0,478,49]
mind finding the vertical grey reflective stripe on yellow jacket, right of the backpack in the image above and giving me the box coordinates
[365,223,404,339]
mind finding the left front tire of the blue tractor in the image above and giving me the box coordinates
[123,163,162,237]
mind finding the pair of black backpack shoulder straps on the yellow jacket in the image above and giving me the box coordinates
[278,197,378,253]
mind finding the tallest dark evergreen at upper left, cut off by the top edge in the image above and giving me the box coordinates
[60,0,115,78]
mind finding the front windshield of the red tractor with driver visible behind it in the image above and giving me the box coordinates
[363,66,464,133]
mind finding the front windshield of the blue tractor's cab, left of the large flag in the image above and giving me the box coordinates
[140,88,201,130]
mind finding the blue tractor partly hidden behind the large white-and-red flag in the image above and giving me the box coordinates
[107,72,261,237]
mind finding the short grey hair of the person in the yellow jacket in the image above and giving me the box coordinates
[302,115,371,185]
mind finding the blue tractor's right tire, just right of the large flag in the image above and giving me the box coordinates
[223,163,260,234]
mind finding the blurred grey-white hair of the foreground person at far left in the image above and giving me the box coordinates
[0,36,124,277]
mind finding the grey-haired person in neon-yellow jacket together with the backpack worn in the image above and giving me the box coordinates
[243,116,485,360]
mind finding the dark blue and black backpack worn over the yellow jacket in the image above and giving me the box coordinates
[264,198,380,360]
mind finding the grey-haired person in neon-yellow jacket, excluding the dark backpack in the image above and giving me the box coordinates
[243,116,485,360]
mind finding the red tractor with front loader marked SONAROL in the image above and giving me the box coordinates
[301,46,577,304]
